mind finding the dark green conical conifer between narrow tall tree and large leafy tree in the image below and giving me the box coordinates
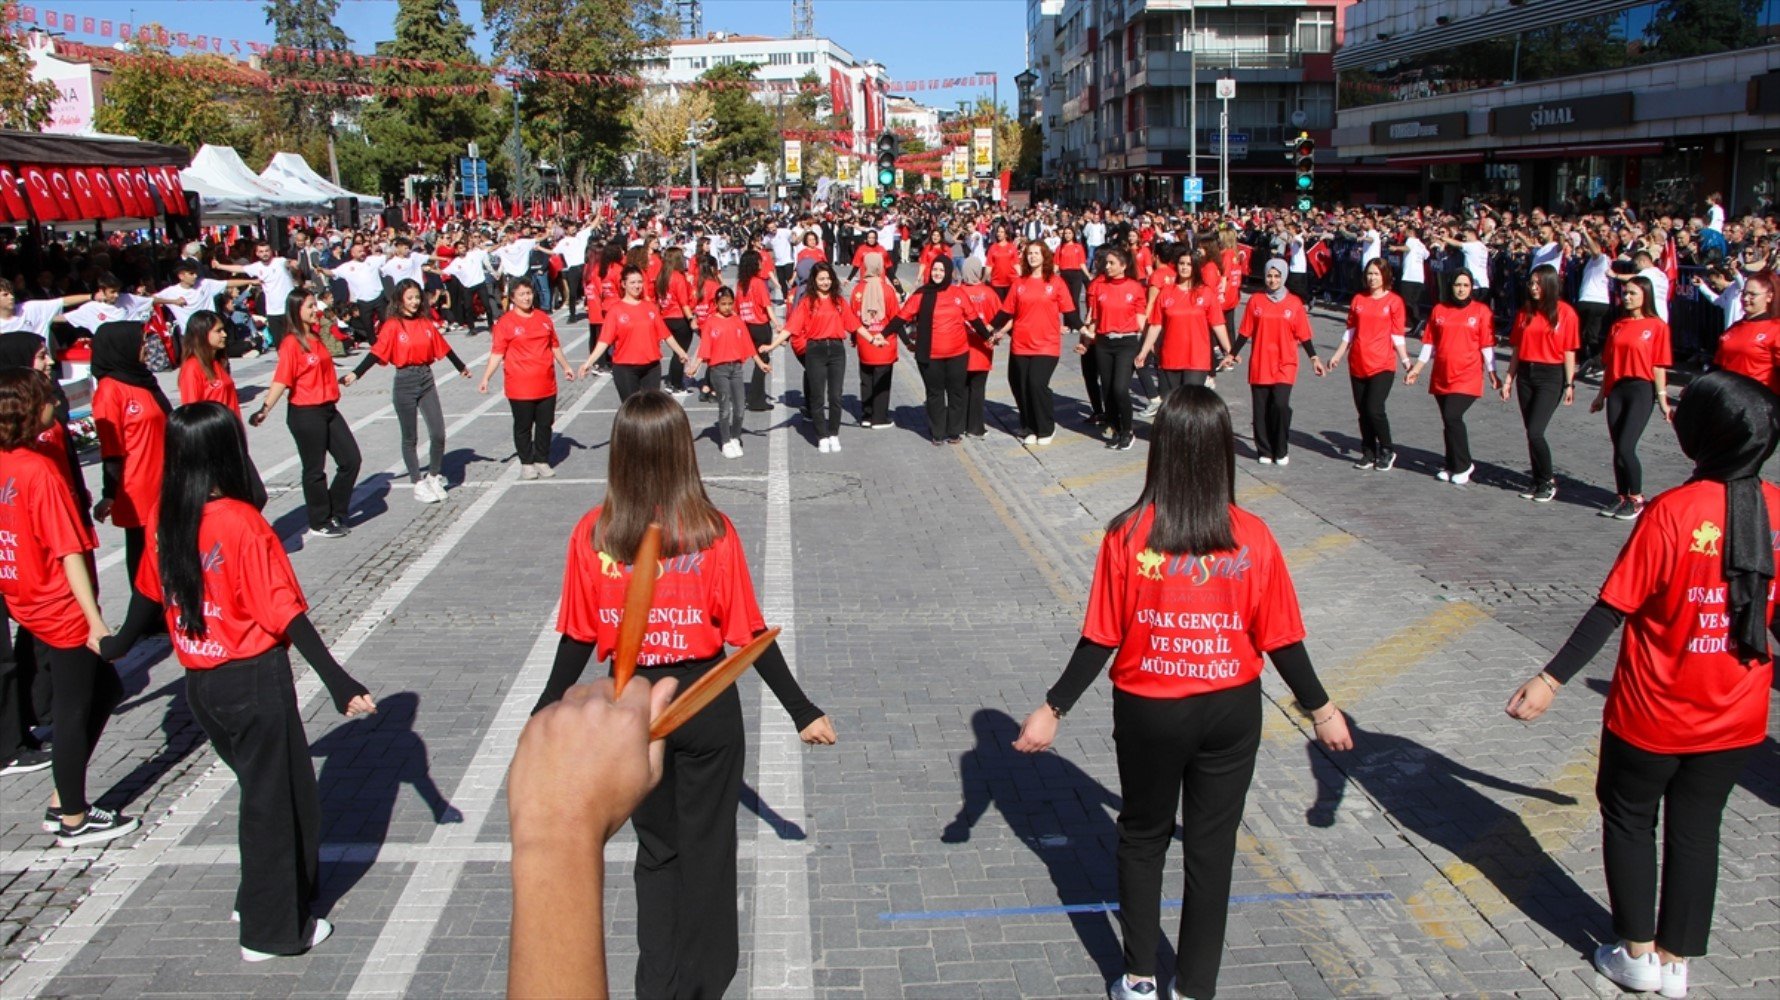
[360,0,506,190]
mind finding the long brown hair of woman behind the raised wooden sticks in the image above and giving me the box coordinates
[593,390,724,562]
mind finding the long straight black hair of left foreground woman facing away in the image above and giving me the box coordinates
[155,402,253,639]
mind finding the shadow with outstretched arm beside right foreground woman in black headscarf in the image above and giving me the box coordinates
[1305,715,1611,956]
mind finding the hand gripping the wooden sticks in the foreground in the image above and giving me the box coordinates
[507,676,678,847]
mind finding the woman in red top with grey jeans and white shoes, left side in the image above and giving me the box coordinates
[340,279,473,504]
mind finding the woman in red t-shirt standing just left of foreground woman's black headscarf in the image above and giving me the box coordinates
[1588,274,1673,521]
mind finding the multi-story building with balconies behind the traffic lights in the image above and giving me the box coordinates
[1047,0,1345,203]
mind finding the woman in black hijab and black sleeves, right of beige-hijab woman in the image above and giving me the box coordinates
[886,256,988,445]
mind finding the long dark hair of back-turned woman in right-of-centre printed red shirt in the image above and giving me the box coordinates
[1107,386,1235,555]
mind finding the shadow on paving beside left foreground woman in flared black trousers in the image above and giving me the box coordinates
[310,690,463,911]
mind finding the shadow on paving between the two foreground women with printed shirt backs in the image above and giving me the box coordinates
[940,708,1125,979]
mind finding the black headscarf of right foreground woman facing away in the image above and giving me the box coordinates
[1675,372,1780,662]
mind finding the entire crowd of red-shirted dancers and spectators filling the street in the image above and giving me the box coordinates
[0,185,1780,998]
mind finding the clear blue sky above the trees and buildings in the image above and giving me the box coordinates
[45,0,1025,105]
